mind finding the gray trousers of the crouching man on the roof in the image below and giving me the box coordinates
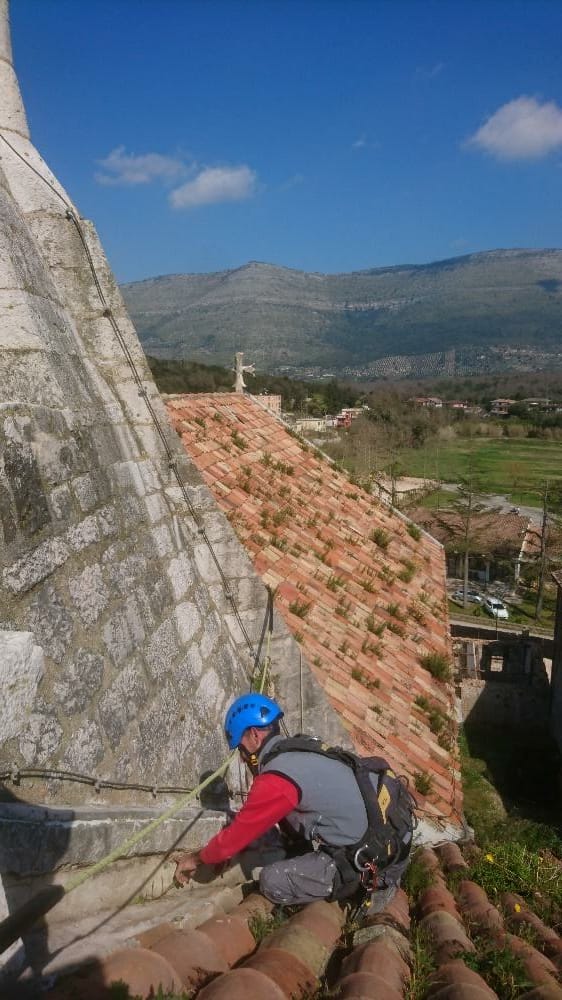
[260,851,409,908]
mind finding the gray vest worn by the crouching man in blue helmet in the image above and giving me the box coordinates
[258,736,367,847]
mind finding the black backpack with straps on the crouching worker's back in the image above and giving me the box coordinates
[260,734,417,884]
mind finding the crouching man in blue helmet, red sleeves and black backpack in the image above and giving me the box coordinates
[175,692,415,912]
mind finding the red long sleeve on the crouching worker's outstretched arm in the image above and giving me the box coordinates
[199,774,299,865]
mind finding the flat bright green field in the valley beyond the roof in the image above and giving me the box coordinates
[399,438,562,507]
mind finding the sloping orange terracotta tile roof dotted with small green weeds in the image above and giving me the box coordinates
[167,393,461,825]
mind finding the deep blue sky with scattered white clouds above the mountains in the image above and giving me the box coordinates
[11,0,562,281]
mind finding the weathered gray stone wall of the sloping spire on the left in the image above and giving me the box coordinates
[0,0,342,803]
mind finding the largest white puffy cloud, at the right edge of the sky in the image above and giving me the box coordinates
[466,96,562,160]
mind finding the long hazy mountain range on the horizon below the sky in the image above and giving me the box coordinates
[122,249,562,378]
